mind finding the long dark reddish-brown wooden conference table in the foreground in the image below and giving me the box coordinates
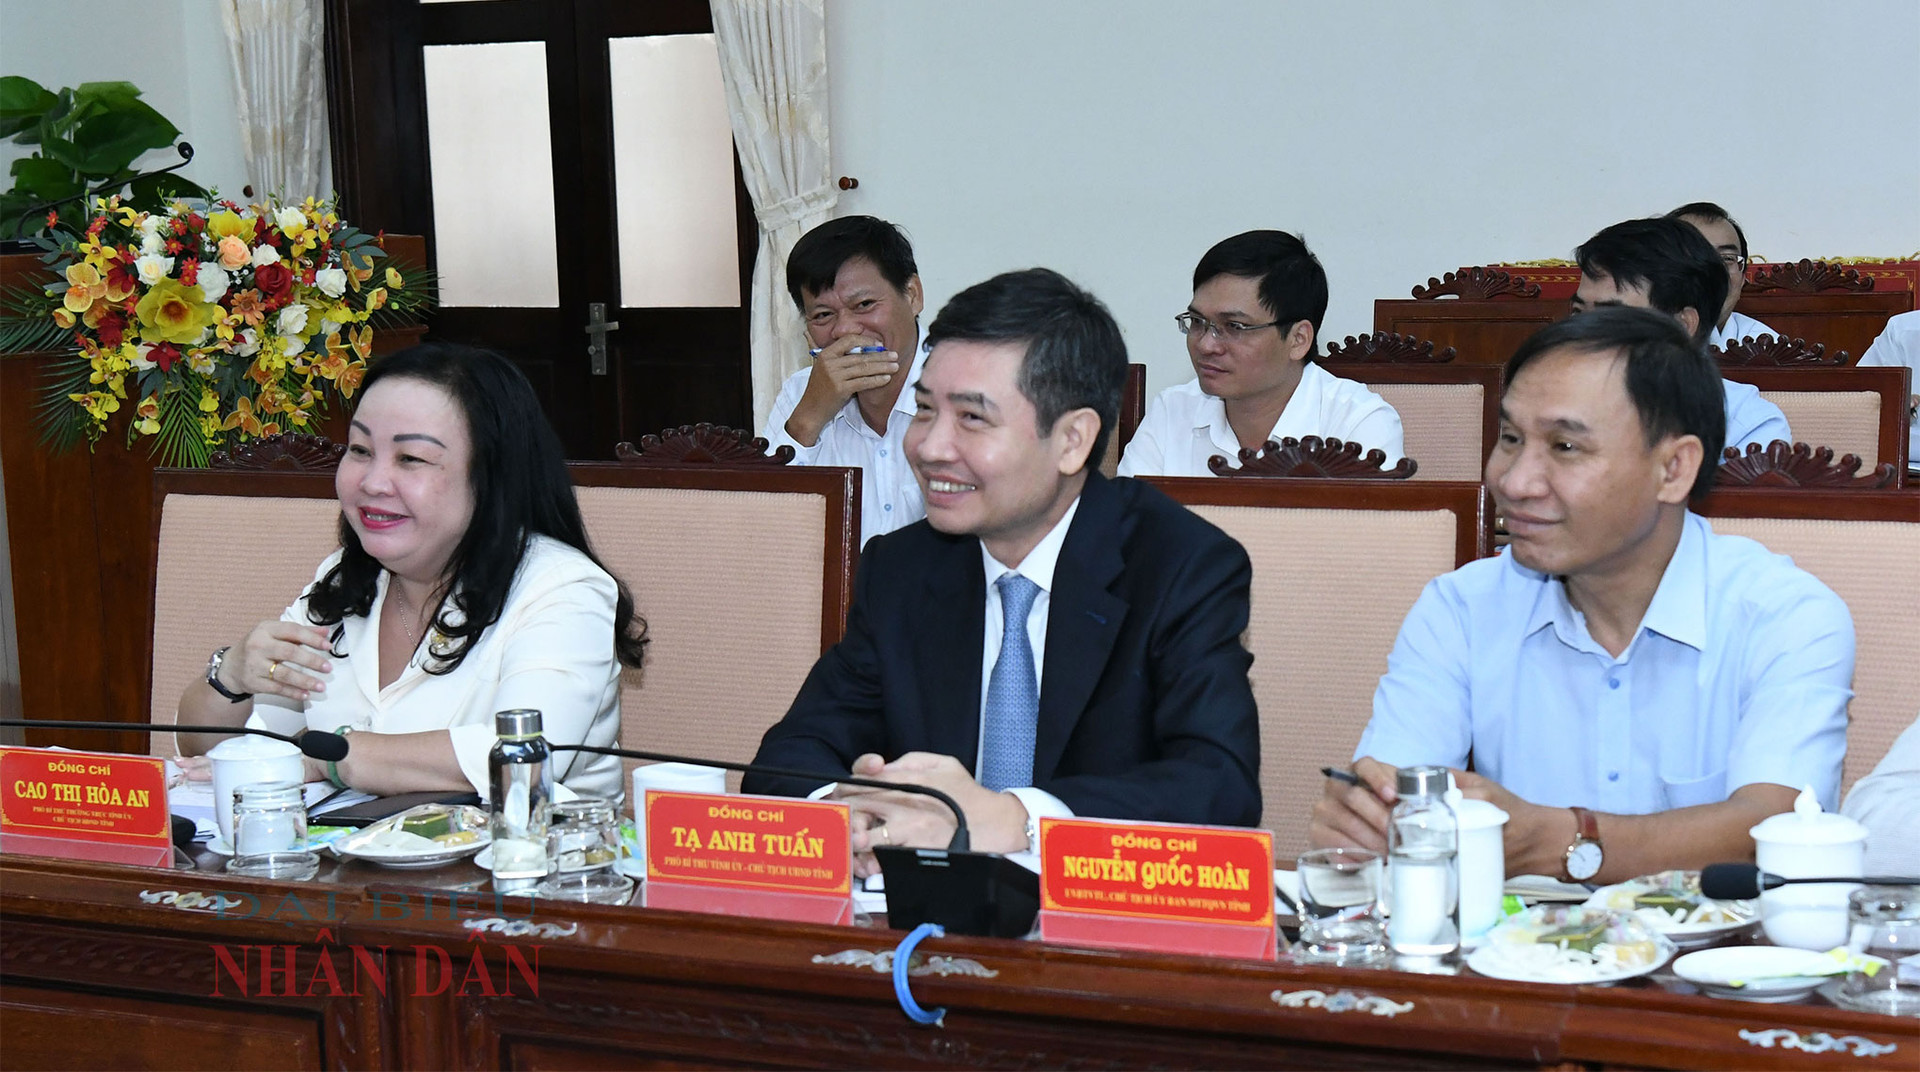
[0,853,1920,1068]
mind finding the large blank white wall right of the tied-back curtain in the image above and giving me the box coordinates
[828,0,1920,390]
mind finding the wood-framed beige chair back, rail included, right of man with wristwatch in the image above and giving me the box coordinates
[1697,488,1920,803]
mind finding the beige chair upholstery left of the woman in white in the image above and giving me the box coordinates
[150,489,340,755]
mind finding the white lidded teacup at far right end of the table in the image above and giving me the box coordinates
[1749,792,1866,951]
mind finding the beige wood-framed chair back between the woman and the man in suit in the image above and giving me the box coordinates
[568,461,860,788]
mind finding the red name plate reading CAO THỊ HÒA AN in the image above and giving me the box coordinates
[0,747,173,866]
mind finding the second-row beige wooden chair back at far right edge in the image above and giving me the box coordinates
[1720,365,1912,473]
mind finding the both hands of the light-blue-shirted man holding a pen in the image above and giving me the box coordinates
[1308,757,1574,874]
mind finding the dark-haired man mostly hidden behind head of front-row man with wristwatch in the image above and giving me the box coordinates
[1572,217,1789,453]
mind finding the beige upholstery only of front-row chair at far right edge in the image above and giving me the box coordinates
[1707,511,1920,792]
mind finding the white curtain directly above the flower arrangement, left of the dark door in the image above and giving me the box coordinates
[219,0,334,204]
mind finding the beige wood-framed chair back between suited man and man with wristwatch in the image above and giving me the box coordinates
[1148,476,1490,861]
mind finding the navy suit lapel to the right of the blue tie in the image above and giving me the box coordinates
[1036,473,1127,784]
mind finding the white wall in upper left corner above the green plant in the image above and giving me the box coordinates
[0,0,246,210]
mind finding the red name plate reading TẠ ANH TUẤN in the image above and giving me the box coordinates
[645,790,852,922]
